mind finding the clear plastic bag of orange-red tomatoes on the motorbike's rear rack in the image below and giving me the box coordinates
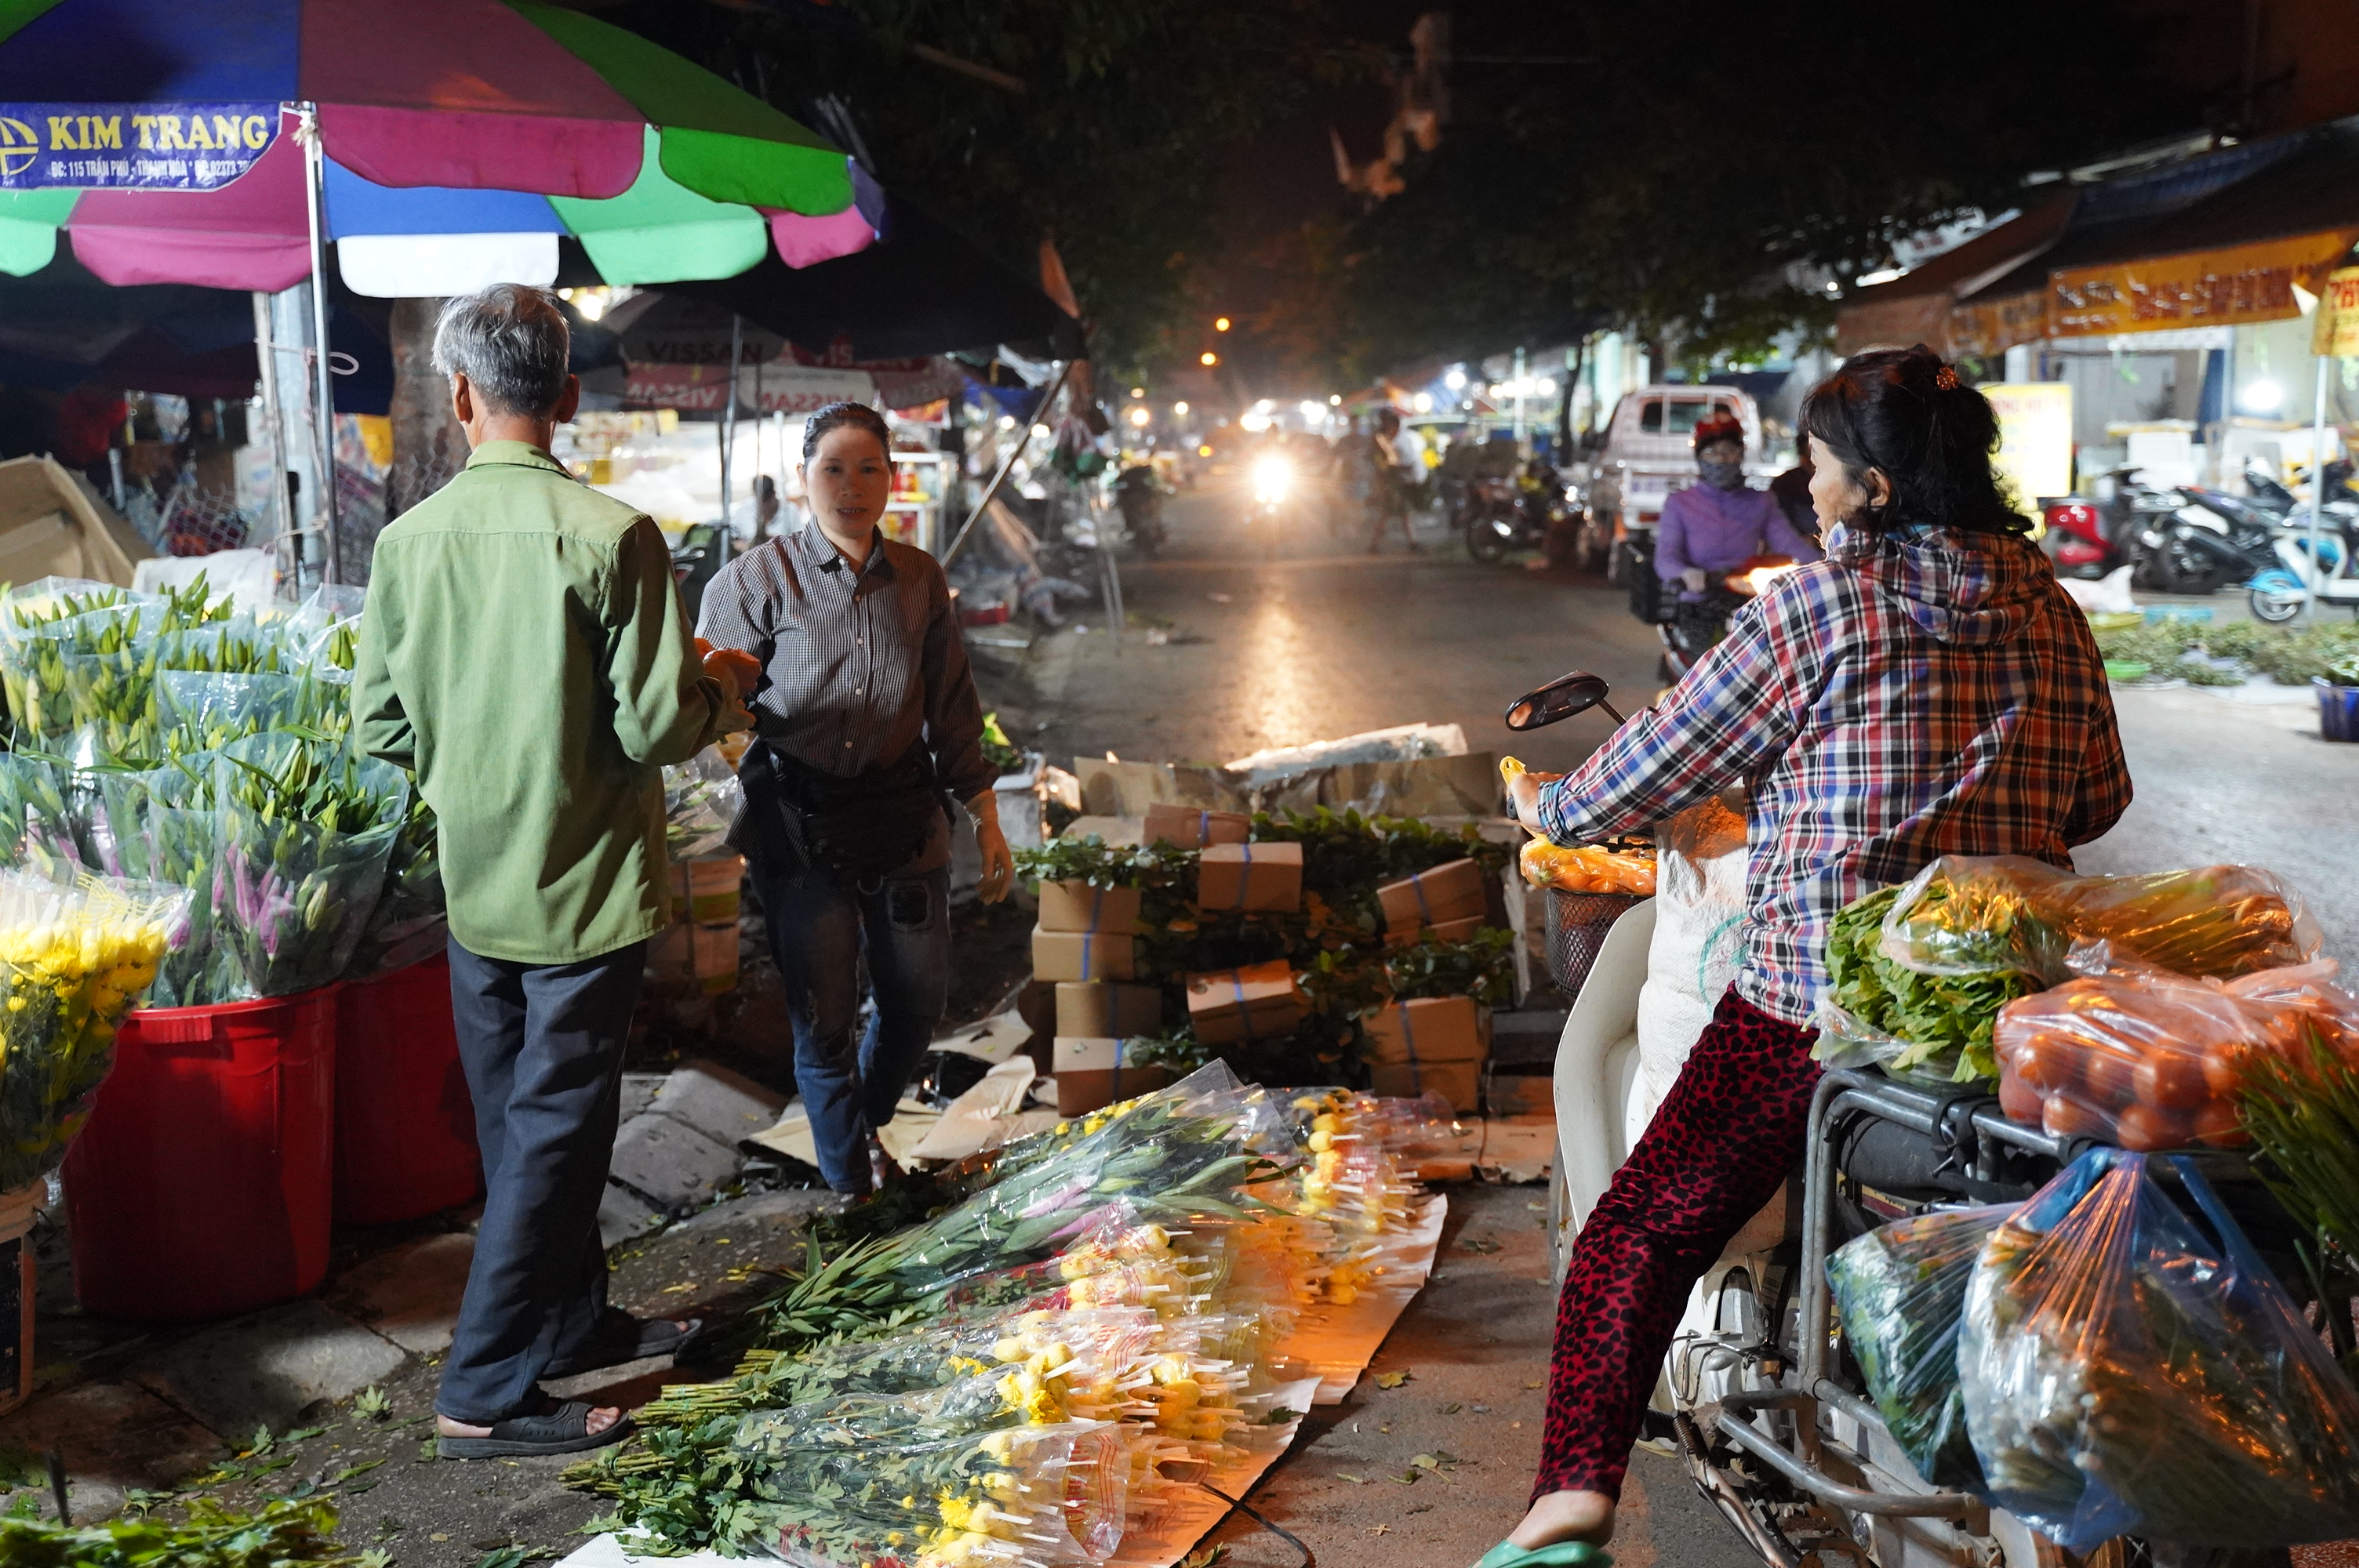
[1994,960,2359,1151]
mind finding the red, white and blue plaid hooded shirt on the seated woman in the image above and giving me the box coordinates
[1540,528,2130,1023]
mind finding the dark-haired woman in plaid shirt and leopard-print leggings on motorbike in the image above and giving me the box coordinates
[1484,344,2130,1568]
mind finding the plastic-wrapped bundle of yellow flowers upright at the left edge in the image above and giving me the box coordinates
[0,870,189,1191]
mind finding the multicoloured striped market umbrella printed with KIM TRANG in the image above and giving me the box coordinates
[0,0,882,295]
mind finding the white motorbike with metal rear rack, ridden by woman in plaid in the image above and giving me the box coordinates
[1507,672,2291,1568]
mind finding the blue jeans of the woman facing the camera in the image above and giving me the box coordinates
[748,861,951,1193]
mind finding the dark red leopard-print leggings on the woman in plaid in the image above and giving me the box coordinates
[1531,990,1819,1500]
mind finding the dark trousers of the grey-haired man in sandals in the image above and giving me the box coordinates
[434,938,646,1425]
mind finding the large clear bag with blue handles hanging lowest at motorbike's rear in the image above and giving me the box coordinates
[1958,1149,2359,1552]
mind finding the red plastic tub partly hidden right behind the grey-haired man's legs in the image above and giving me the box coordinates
[335,953,484,1226]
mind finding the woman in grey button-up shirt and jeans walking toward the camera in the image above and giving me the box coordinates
[698,403,1014,1193]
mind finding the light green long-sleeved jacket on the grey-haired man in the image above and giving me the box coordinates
[351,441,729,964]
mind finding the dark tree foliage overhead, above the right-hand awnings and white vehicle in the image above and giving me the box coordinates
[1299,0,2194,377]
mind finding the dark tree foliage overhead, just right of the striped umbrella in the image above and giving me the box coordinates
[609,0,1338,368]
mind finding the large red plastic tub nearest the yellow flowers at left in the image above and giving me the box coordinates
[66,985,337,1323]
